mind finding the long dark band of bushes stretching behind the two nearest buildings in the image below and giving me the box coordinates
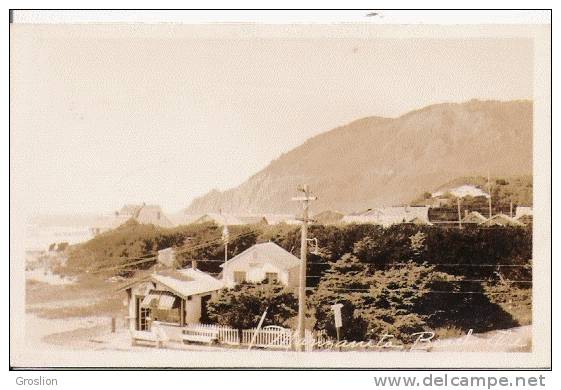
[64,219,532,286]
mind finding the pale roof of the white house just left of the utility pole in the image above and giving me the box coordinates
[221,242,300,270]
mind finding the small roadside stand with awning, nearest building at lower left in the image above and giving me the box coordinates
[119,268,224,340]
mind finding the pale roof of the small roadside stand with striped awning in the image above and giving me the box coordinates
[119,268,224,298]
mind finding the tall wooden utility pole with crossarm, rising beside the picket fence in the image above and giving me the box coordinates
[292,184,317,351]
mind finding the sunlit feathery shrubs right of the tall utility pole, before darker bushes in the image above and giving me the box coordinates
[311,255,517,343]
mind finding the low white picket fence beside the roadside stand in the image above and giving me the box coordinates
[186,324,327,351]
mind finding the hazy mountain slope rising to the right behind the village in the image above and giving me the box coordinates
[186,100,532,213]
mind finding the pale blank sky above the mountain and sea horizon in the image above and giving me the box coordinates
[11,25,533,213]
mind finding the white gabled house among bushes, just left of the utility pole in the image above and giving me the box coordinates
[221,242,300,287]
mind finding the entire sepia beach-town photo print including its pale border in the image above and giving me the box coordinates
[9,10,552,369]
